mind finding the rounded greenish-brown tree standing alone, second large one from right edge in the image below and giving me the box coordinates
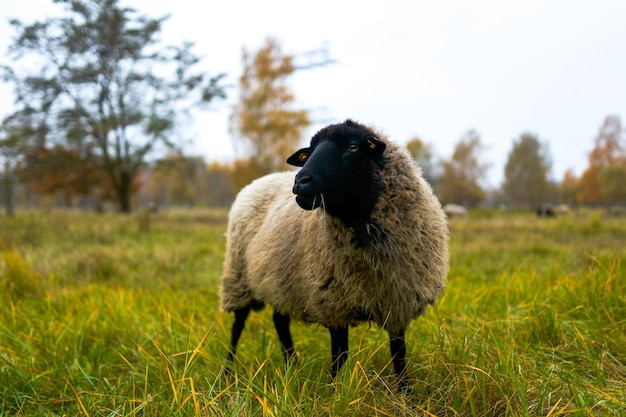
[502,133,552,207]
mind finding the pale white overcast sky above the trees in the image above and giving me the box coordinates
[0,0,626,186]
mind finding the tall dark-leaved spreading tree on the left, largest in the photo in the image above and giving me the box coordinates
[4,0,224,212]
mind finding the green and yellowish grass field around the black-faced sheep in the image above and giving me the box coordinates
[0,210,626,416]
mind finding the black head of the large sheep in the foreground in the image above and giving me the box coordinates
[287,120,385,225]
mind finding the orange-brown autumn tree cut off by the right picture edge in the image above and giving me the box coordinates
[578,116,626,205]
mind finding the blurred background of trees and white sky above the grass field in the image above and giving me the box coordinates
[0,0,626,215]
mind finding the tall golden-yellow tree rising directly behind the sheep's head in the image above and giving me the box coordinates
[230,38,330,186]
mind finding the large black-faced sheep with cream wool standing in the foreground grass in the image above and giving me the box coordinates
[220,119,449,389]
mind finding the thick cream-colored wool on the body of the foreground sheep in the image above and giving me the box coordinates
[221,132,448,334]
